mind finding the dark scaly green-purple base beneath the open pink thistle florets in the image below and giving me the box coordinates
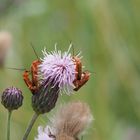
[32,83,59,114]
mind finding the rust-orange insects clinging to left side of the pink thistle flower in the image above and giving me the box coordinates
[23,44,41,94]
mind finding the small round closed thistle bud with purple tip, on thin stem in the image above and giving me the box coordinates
[1,87,23,111]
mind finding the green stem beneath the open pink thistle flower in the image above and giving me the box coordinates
[23,113,39,140]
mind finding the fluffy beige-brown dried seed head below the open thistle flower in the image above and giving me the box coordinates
[52,101,92,138]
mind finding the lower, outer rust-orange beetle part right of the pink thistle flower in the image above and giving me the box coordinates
[73,71,90,91]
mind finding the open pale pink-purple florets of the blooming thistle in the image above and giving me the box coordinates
[39,45,76,94]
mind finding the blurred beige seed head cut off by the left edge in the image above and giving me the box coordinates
[0,31,12,66]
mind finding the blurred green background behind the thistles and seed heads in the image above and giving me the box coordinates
[0,0,140,140]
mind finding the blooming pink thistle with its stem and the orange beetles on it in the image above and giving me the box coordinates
[23,44,90,140]
